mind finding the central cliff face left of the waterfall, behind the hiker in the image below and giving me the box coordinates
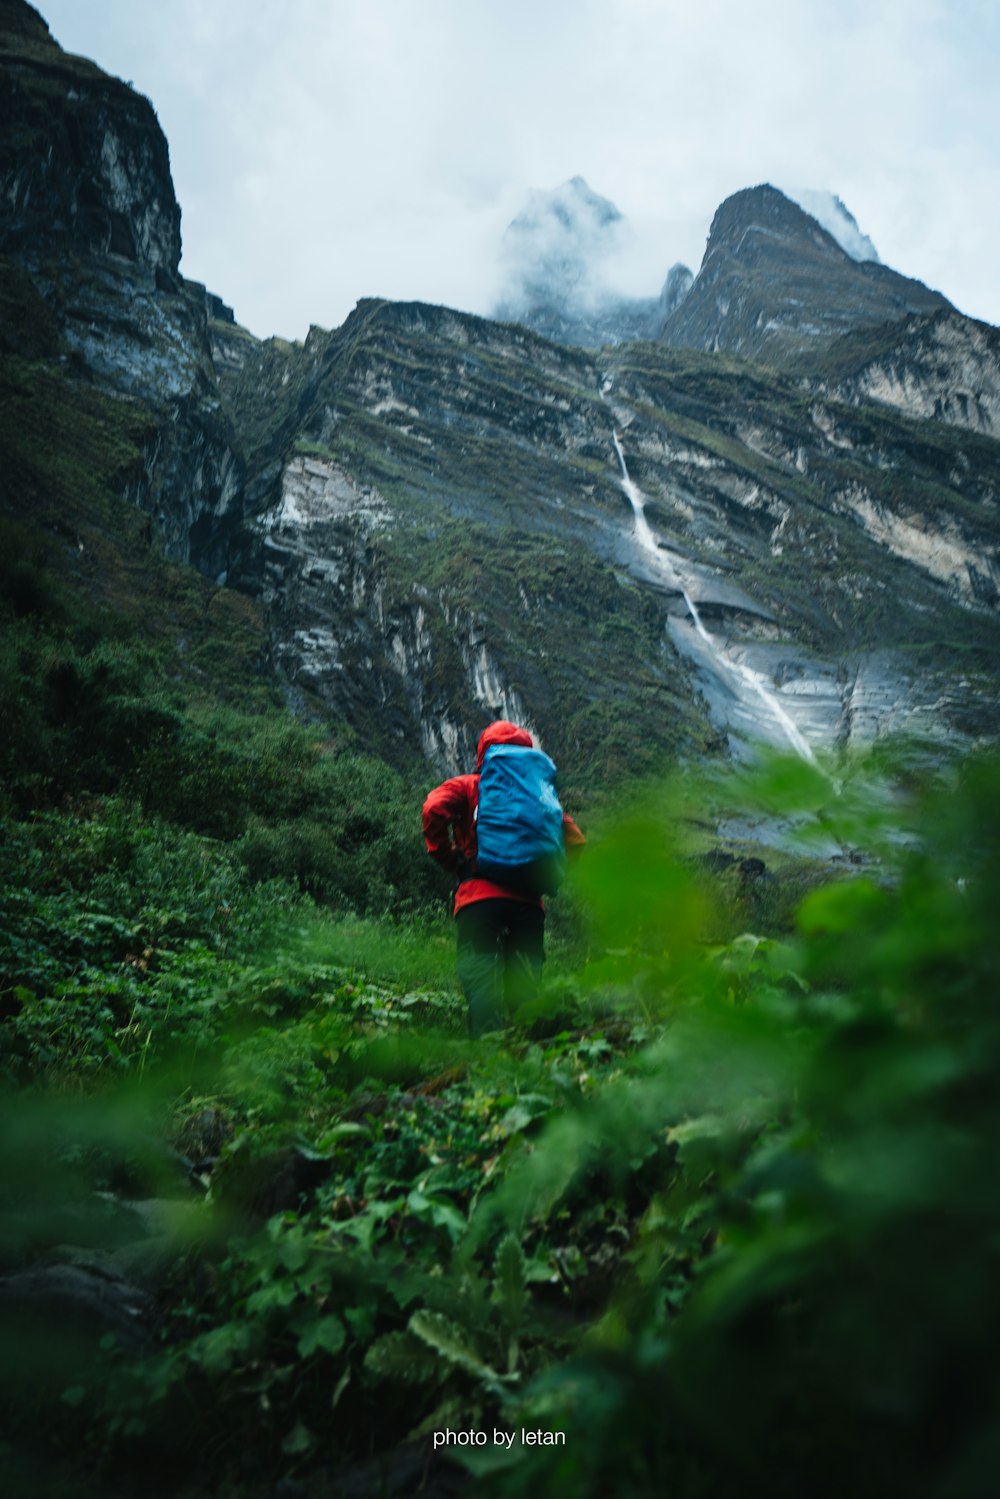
[226,303,708,775]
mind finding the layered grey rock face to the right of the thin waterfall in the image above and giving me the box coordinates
[599,349,1000,747]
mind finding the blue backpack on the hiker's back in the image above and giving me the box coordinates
[475,745,565,895]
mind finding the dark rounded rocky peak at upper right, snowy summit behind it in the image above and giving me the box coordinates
[660,186,1000,433]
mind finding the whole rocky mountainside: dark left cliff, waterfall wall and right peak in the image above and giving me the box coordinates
[0,0,1000,791]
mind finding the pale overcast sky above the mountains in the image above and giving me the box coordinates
[34,0,1000,339]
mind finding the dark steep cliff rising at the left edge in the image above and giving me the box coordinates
[0,0,241,573]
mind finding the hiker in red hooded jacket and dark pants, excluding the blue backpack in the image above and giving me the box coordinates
[423,720,585,1036]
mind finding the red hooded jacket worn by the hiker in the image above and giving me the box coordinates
[424,718,586,916]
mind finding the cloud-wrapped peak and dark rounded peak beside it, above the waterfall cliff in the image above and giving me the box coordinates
[495,177,997,449]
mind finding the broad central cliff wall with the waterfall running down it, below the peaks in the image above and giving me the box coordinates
[218,303,1000,776]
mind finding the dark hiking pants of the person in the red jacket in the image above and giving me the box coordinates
[456,898,546,1036]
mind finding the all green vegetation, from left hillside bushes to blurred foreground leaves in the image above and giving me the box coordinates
[0,286,1000,1499]
